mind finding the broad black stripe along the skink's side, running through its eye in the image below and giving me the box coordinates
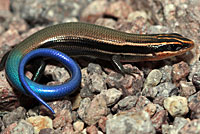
[41,38,187,54]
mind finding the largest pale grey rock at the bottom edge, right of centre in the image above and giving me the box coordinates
[106,111,156,134]
